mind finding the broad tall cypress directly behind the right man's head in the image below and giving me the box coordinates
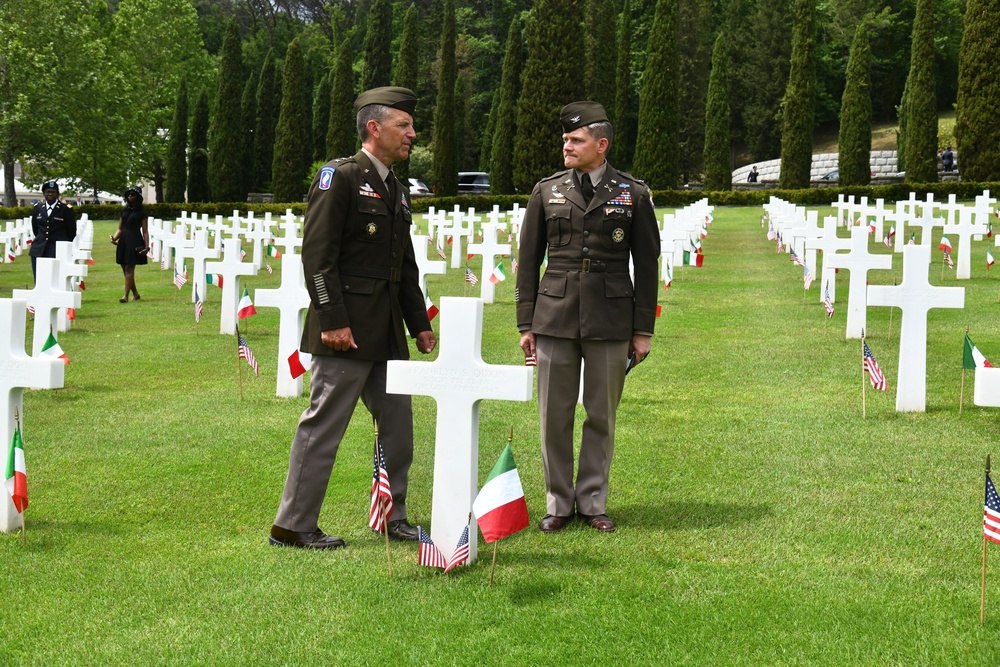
[514,0,584,192]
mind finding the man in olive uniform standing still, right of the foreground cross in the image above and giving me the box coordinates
[517,102,660,533]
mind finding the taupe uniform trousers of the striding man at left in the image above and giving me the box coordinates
[274,355,413,532]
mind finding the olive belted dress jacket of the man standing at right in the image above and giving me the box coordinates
[517,165,660,340]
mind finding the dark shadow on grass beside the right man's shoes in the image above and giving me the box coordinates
[614,501,772,531]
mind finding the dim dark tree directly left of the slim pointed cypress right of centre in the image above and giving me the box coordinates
[677,0,713,183]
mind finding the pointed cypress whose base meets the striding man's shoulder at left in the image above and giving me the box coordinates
[271,37,312,202]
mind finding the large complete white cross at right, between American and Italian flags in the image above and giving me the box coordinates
[868,245,965,412]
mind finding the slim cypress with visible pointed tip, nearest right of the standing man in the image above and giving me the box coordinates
[705,32,733,190]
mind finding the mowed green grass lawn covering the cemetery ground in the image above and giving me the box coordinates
[0,208,1000,665]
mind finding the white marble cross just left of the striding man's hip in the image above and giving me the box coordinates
[254,253,309,396]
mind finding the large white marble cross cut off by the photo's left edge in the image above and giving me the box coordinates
[0,298,66,533]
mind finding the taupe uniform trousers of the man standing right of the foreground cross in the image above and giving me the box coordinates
[535,335,629,516]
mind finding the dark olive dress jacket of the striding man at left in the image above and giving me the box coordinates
[300,151,431,361]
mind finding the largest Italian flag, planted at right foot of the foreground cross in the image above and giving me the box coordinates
[472,443,529,544]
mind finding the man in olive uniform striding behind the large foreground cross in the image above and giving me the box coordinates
[270,87,437,549]
